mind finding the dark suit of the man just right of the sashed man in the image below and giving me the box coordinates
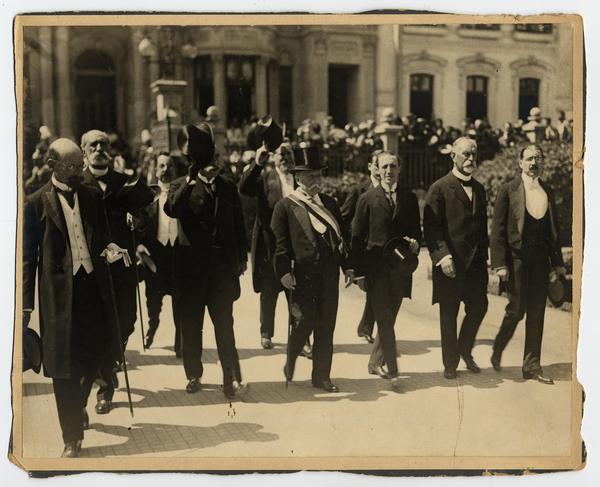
[352,186,421,374]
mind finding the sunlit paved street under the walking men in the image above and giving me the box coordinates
[23,253,571,464]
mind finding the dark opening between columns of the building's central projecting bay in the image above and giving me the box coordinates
[225,56,254,125]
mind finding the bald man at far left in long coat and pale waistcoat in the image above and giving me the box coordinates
[23,139,131,457]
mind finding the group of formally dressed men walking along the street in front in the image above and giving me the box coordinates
[23,113,565,457]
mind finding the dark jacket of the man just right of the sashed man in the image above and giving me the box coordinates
[351,186,421,297]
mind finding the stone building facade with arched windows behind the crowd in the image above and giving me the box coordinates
[24,24,572,151]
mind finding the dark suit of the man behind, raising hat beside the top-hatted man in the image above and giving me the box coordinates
[240,162,296,338]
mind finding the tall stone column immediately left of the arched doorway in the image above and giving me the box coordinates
[56,27,73,137]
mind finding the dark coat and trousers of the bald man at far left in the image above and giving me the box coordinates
[23,182,118,442]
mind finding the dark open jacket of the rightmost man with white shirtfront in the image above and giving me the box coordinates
[490,177,563,275]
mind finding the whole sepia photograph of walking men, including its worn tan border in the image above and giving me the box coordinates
[9,13,585,472]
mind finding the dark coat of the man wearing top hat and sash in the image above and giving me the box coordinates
[271,193,348,279]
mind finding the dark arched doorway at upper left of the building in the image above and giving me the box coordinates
[75,49,117,136]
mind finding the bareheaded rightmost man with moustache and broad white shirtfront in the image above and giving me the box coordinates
[491,145,565,384]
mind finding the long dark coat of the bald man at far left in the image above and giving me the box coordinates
[23,182,117,379]
